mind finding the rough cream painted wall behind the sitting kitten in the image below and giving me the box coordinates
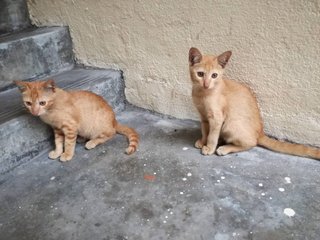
[28,0,320,146]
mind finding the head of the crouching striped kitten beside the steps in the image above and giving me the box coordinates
[14,80,55,116]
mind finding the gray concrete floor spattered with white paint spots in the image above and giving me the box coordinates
[0,108,320,240]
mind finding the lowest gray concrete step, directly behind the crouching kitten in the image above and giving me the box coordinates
[0,68,125,173]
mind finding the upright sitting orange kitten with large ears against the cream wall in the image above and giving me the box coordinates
[189,48,320,159]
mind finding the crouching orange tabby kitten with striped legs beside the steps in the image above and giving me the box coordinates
[15,80,139,161]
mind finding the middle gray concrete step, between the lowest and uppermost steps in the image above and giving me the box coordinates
[0,27,74,90]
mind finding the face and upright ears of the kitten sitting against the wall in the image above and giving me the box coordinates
[189,48,232,89]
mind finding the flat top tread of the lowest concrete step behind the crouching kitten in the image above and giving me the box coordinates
[0,67,122,124]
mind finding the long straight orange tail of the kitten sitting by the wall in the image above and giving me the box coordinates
[258,135,320,160]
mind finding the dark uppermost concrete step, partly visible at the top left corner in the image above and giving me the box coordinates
[0,0,31,34]
